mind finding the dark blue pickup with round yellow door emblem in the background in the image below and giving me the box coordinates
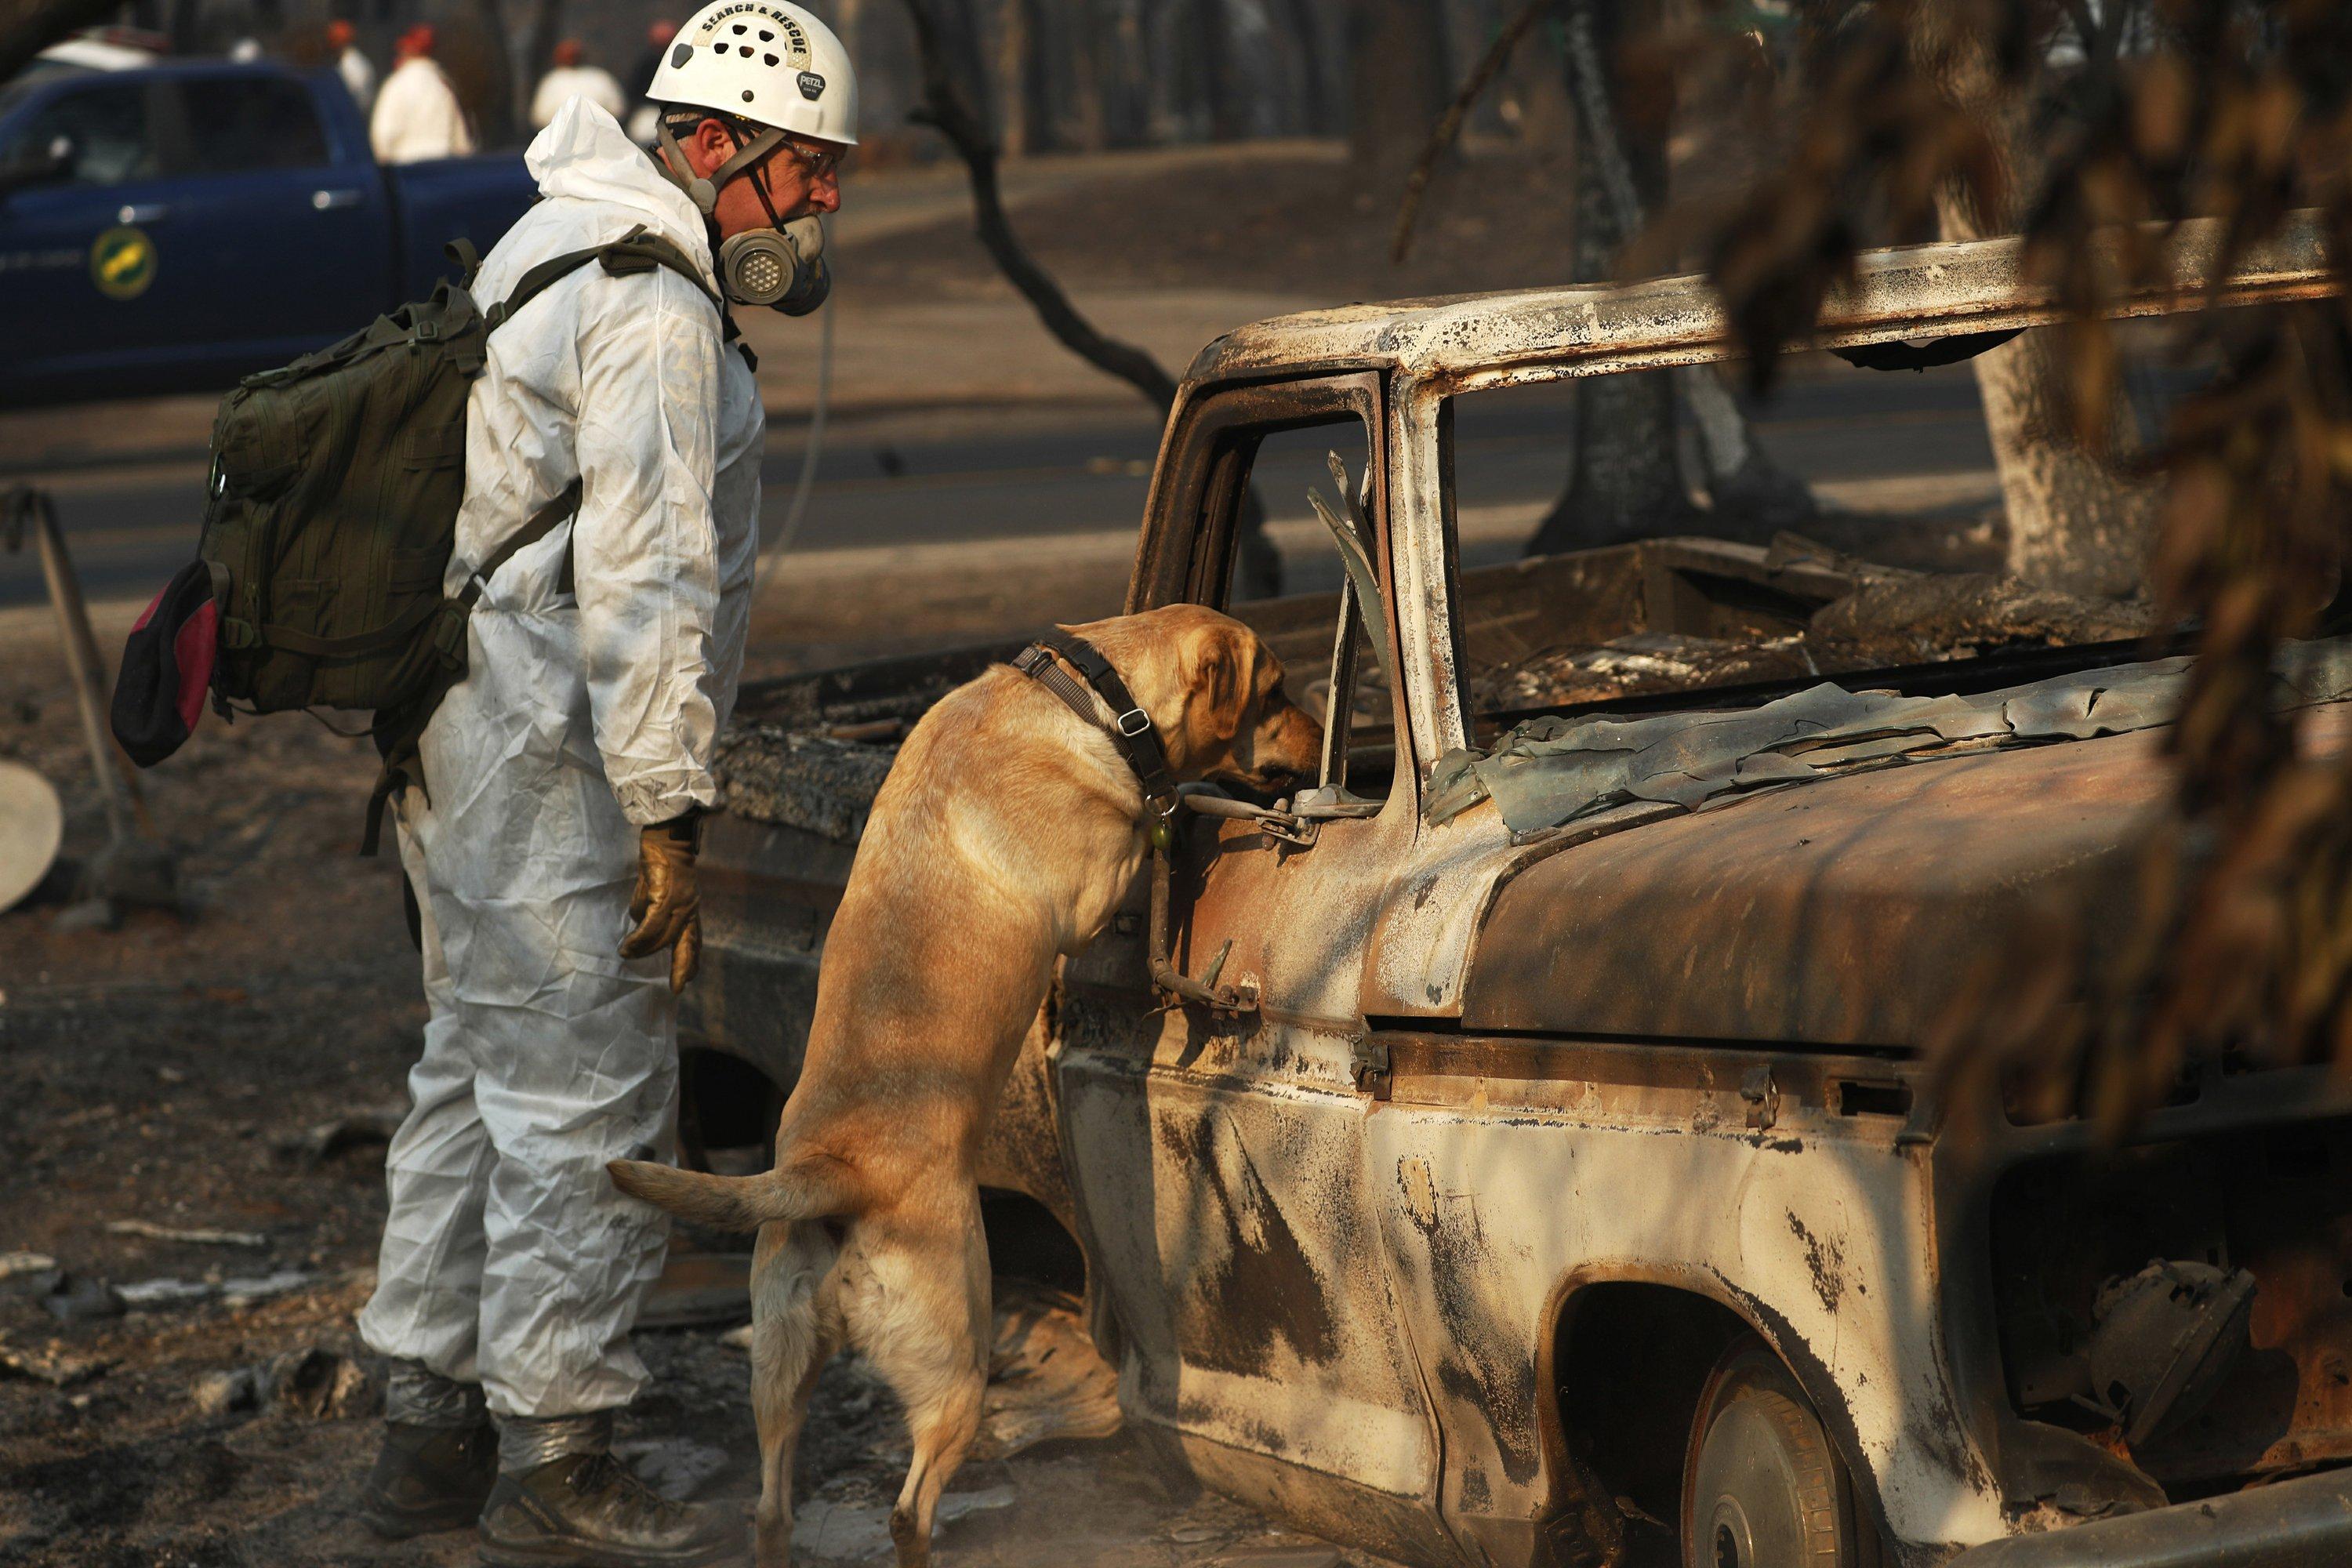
[0,59,536,407]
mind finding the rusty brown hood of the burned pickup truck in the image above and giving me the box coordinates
[1461,703,2352,1048]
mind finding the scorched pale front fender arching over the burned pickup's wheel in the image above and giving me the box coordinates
[1367,1100,2004,1561]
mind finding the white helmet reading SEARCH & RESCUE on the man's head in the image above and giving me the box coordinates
[644,0,858,146]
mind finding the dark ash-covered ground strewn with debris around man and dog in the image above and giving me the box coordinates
[0,554,1369,1568]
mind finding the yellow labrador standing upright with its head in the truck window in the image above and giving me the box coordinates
[612,604,1322,1568]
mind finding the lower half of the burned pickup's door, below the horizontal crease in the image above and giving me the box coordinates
[1058,1044,1437,1502]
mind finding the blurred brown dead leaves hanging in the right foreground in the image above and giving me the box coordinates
[1656,0,2352,1133]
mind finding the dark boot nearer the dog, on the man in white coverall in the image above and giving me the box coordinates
[480,1453,743,1568]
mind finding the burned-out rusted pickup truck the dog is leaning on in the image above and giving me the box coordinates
[684,230,2352,1568]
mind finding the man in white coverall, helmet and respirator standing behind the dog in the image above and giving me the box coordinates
[360,0,856,1566]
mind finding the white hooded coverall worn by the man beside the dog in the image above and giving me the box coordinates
[360,99,764,1417]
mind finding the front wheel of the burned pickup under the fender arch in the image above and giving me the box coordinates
[1682,1335,1863,1568]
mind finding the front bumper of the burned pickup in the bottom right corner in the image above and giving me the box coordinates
[1950,1469,2352,1568]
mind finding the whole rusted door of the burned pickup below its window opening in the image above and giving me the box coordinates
[1056,794,1451,1561]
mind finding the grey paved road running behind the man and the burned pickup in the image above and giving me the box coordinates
[0,369,1992,607]
